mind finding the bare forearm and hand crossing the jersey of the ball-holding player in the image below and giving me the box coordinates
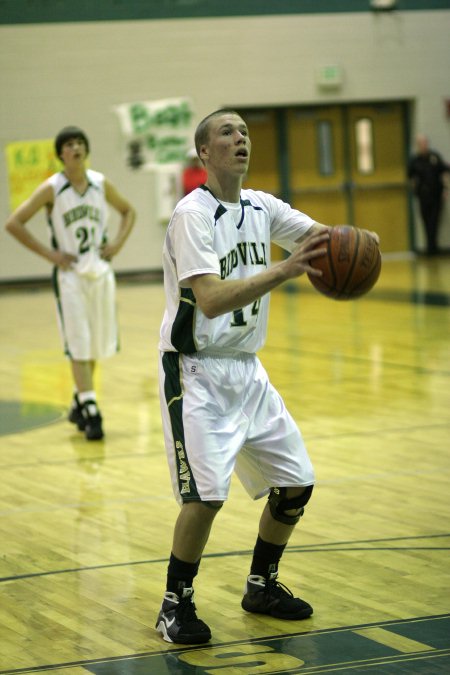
[190,227,329,319]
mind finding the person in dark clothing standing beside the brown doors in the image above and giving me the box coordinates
[408,134,450,255]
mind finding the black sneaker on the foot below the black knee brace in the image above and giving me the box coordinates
[241,574,313,620]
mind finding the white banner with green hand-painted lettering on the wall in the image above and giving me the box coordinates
[114,98,194,169]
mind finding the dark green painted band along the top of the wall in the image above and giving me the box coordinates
[0,0,450,24]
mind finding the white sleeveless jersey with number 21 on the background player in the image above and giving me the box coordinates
[48,169,110,278]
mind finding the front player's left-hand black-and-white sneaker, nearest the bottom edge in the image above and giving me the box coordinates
[155,588,211,645]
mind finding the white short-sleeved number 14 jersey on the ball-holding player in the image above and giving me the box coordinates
[159,187,314,354]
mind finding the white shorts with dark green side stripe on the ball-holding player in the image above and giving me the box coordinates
[159,352,314,504]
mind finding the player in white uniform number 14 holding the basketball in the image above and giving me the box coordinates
[156,110,378,644]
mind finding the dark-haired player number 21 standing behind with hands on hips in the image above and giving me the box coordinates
[6,126,135,440]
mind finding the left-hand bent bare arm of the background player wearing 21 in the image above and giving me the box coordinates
[5,182,76,269]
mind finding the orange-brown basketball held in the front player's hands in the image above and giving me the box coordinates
[308,225,381,300]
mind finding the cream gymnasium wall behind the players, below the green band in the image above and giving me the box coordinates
[0,2,450,281]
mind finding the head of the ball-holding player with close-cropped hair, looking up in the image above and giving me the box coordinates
[200,113,251,176]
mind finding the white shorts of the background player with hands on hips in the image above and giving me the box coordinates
[54,269,119,361]
